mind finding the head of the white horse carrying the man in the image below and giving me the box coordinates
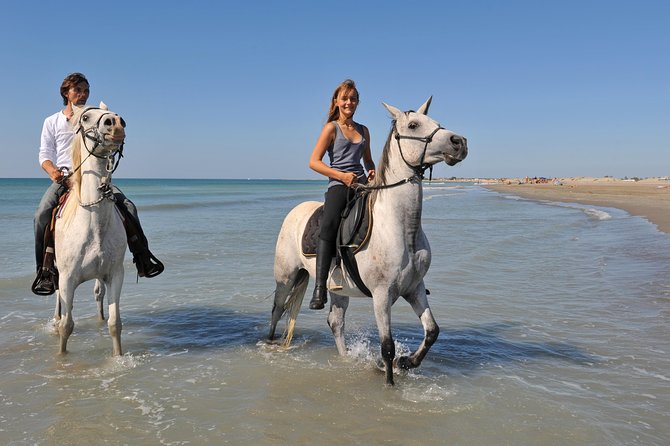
[72,102,126,157]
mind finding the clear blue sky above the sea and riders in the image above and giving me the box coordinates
[0,0,670,178]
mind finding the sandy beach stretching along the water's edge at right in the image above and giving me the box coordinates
[485,177,670,234]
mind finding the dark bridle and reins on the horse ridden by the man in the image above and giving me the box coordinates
[64,107,125,207]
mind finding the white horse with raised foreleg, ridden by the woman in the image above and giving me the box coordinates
[268,98,468,385]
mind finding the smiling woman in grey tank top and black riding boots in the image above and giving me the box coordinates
[309,79,375,310]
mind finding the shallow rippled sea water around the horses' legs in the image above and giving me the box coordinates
[0,180,670,445]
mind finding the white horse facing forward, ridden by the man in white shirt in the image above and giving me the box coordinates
[54,102,127,355]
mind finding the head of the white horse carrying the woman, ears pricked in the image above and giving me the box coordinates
[384,96,468,172]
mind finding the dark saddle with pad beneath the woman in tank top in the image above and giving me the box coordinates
[302,192,372,297]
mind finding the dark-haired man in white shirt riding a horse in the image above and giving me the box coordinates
[32,73,163,295]
